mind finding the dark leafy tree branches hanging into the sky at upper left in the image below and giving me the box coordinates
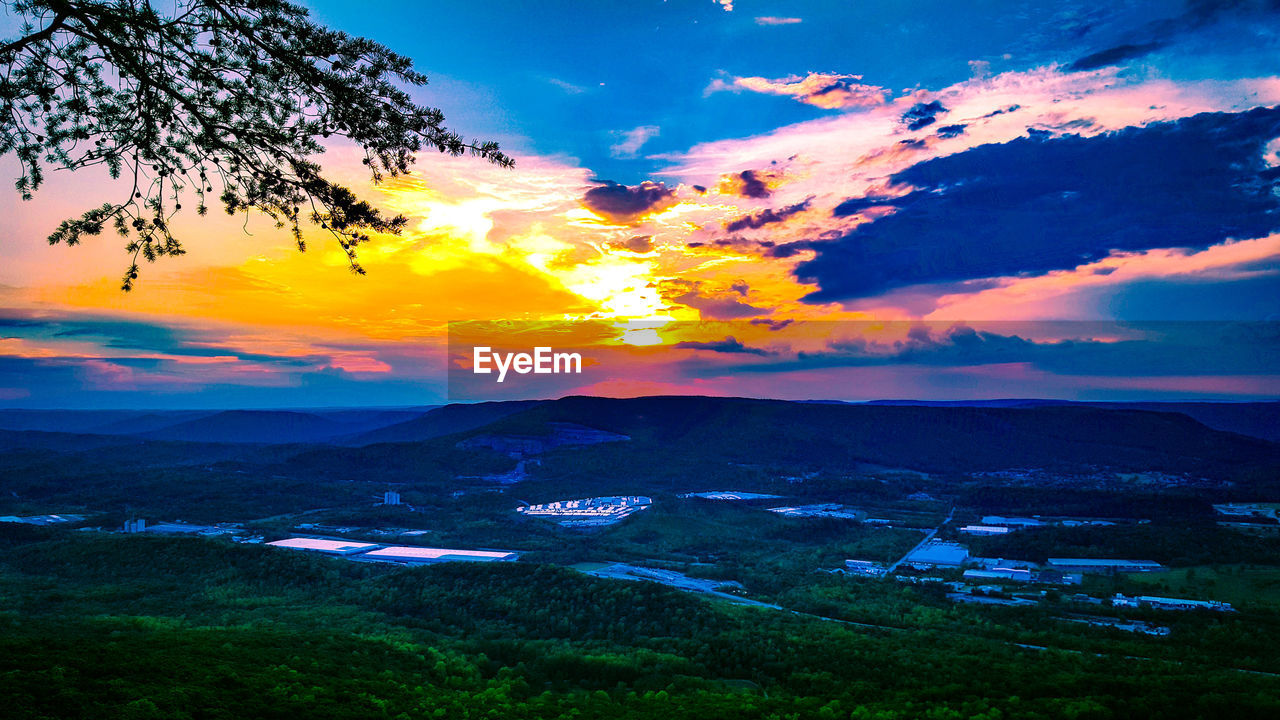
[0,0,513,290]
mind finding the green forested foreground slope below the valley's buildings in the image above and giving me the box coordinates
[0,527,1280,719]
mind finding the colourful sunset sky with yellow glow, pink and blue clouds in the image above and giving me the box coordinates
[0,0,1280,407]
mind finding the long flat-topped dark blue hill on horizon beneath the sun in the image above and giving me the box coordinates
[422,397,1280,473]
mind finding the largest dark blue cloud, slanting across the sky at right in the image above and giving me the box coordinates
[798,108,1280,302]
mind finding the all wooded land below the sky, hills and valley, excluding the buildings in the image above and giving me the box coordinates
[0,398,1280,720]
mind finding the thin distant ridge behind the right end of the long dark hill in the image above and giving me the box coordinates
[867,398,1280,442]
